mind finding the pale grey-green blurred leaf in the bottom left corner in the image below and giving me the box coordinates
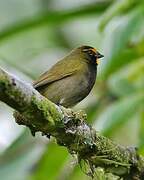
[0,131,43,180]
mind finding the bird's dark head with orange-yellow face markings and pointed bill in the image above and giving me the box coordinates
[77,46,104,65]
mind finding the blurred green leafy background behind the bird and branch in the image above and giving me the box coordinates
[0,0,144,180]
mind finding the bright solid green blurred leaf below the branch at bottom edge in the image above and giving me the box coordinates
[32,142,69,180]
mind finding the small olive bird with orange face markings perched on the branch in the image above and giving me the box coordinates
[33,46,104,108]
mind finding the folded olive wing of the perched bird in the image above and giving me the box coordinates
[33,60,80,88]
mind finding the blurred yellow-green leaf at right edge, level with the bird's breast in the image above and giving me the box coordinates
[108,58,144,96]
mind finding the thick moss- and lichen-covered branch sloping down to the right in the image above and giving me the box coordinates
[0,69,144,179]
